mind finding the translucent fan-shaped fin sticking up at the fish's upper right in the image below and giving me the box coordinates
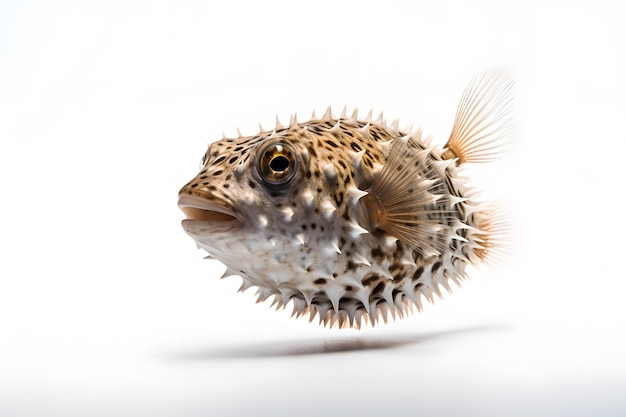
[442,71,513,164]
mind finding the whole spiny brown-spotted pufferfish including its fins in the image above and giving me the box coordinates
[178,71,513,328]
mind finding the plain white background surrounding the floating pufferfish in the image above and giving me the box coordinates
[0,0,626,416]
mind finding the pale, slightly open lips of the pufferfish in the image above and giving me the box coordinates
[178,195,243,235]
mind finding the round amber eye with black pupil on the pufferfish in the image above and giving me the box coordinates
[257,143,297,188]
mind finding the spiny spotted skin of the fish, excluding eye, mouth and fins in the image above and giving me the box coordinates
[180,112,476,327]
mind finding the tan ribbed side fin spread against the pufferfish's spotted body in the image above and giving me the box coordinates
[360,136,453,256]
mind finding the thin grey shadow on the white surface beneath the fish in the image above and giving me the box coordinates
[166,326,509,360]
